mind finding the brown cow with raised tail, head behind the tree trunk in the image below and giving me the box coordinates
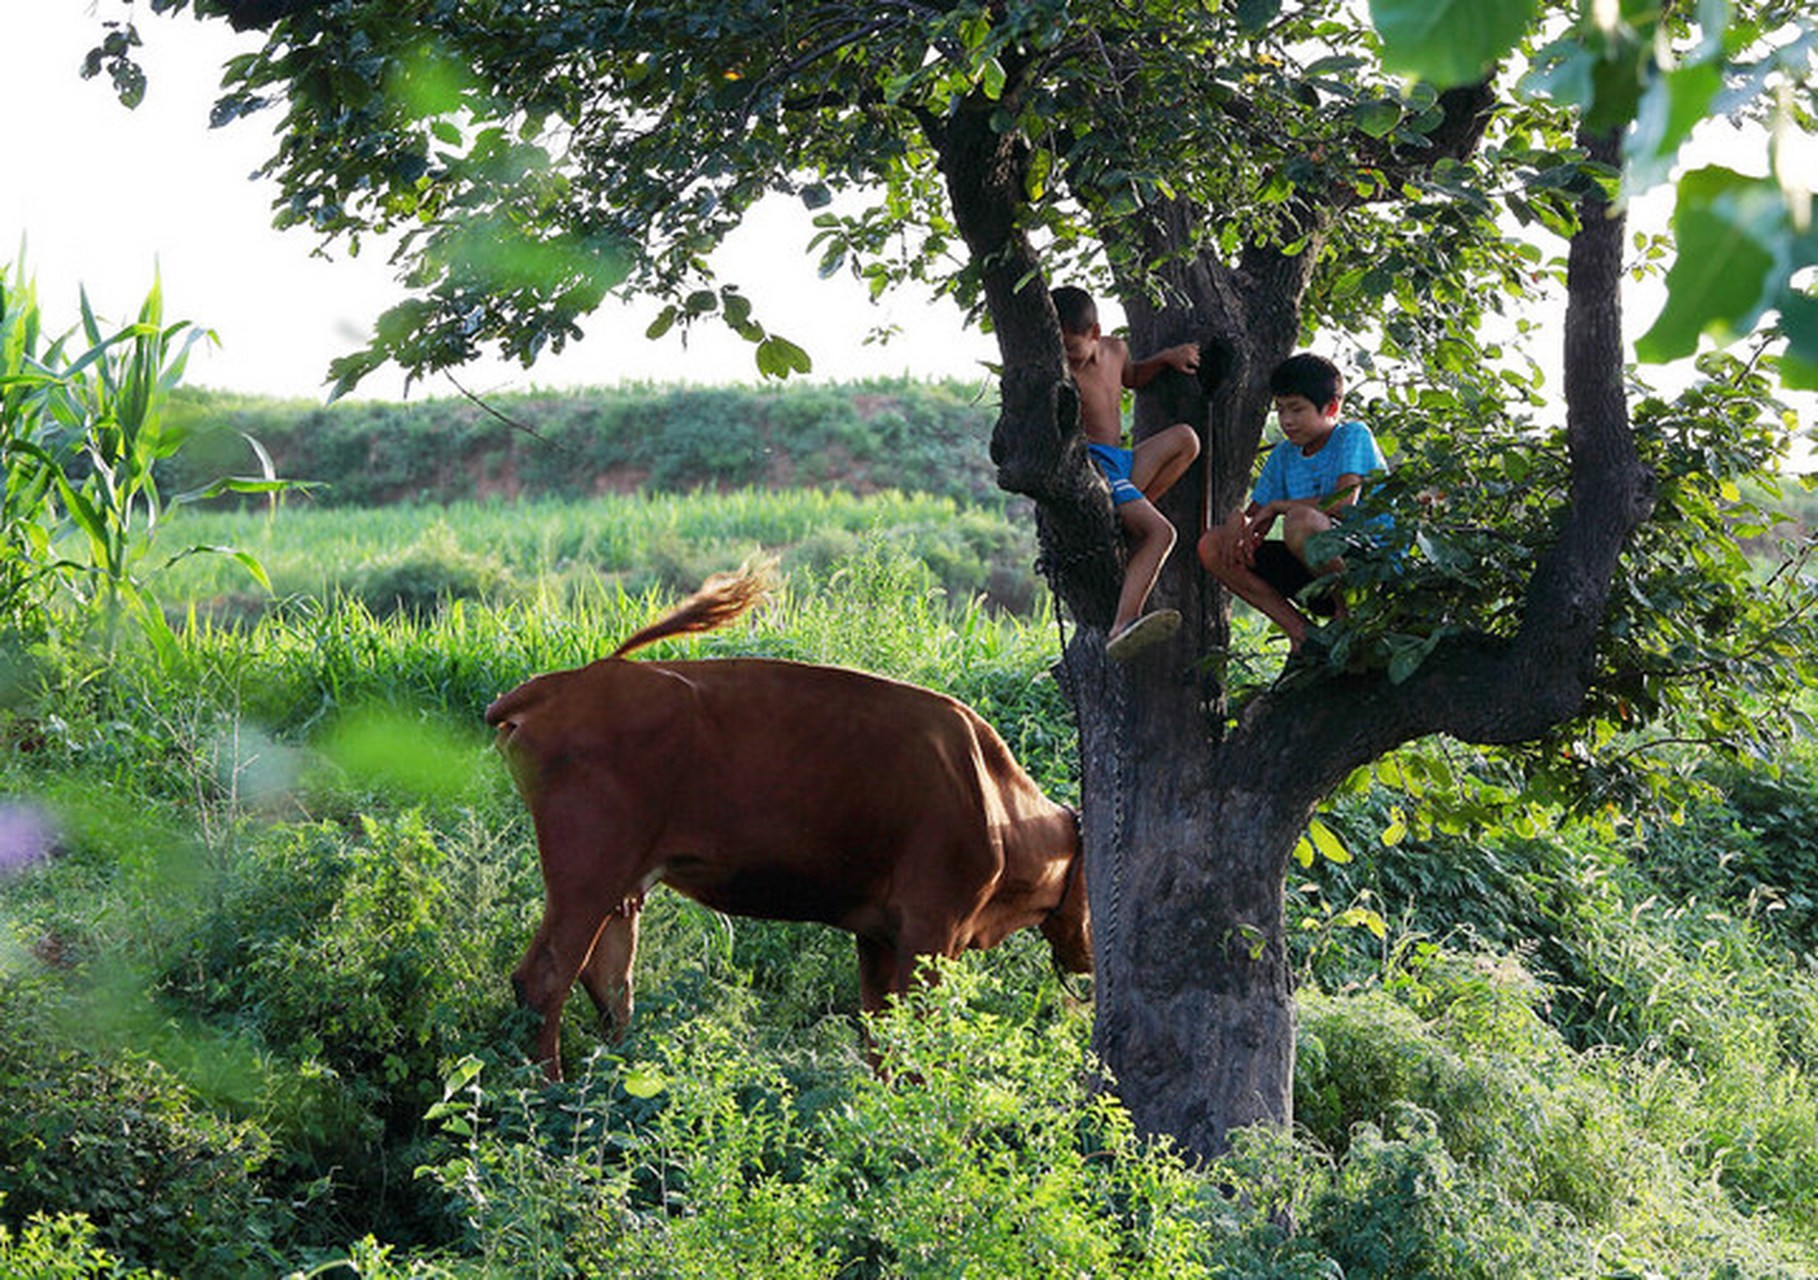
[485,571,1093,1080]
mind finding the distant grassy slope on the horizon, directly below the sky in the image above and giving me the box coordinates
[167,380,1004,507]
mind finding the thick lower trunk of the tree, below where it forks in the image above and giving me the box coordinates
[1067,636,1307,1155]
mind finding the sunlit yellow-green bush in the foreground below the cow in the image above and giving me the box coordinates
[416,965,1287,1278]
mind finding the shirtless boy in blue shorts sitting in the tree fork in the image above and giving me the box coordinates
[1053,285,1200,662]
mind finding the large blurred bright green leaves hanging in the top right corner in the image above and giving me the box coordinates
[1371,0,1818,389]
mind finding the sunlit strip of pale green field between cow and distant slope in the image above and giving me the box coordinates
[156,489,1045,616]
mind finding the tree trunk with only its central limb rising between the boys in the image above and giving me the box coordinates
[1069,205,1318,1155]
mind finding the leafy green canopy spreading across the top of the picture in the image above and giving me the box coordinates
[85,0,1818,391]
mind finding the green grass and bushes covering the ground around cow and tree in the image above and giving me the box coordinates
[0,493,1818,1280]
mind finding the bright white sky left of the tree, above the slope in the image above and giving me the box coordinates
[0,0,996,400]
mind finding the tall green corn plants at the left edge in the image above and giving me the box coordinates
[0,267,289,653]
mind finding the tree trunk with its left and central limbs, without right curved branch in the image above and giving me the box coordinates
[931,95,1338,1155]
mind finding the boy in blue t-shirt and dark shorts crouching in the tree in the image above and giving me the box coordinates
[1200,353,1387,651]
